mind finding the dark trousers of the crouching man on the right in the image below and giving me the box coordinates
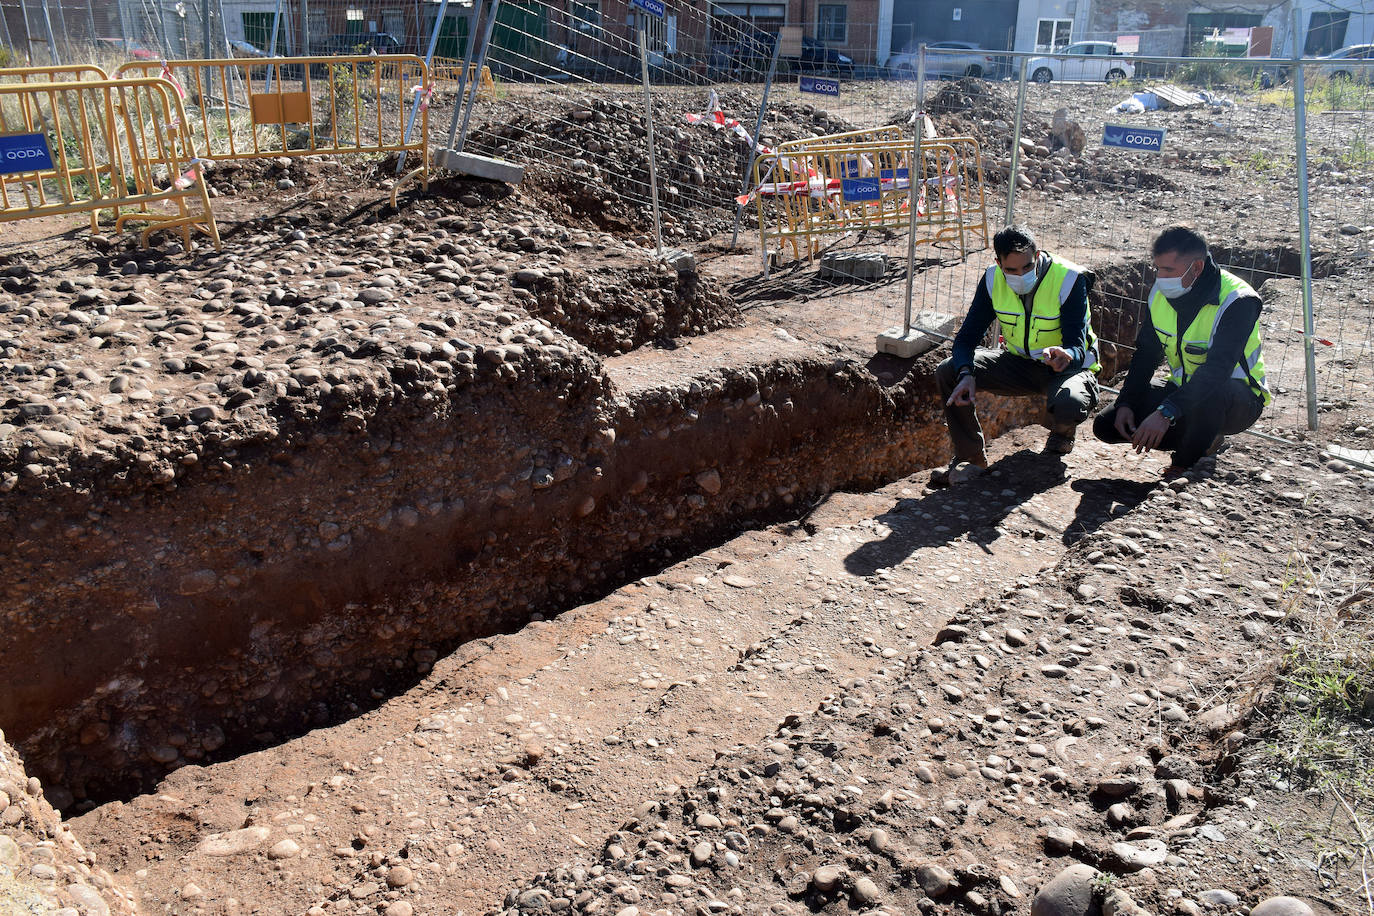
[1092,379,1264,467]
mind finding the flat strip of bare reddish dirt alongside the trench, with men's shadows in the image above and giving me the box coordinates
[74,430,1324,913]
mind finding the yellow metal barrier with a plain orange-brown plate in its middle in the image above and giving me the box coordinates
[115,54,434,206]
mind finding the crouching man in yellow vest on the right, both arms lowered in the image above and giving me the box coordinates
[1092,227,1274,478]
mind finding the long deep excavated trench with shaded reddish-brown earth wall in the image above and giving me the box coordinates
[0,245,1313,808]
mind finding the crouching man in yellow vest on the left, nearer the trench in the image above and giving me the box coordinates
[932,227,1101,486]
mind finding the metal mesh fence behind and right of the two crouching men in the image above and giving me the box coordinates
[918,49,1374,449]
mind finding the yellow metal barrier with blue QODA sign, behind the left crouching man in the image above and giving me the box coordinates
[753,137,988,260]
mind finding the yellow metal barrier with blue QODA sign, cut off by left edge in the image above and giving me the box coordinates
[0,80,220,249]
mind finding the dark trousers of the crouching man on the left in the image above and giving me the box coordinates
[936,347,1098,464]
